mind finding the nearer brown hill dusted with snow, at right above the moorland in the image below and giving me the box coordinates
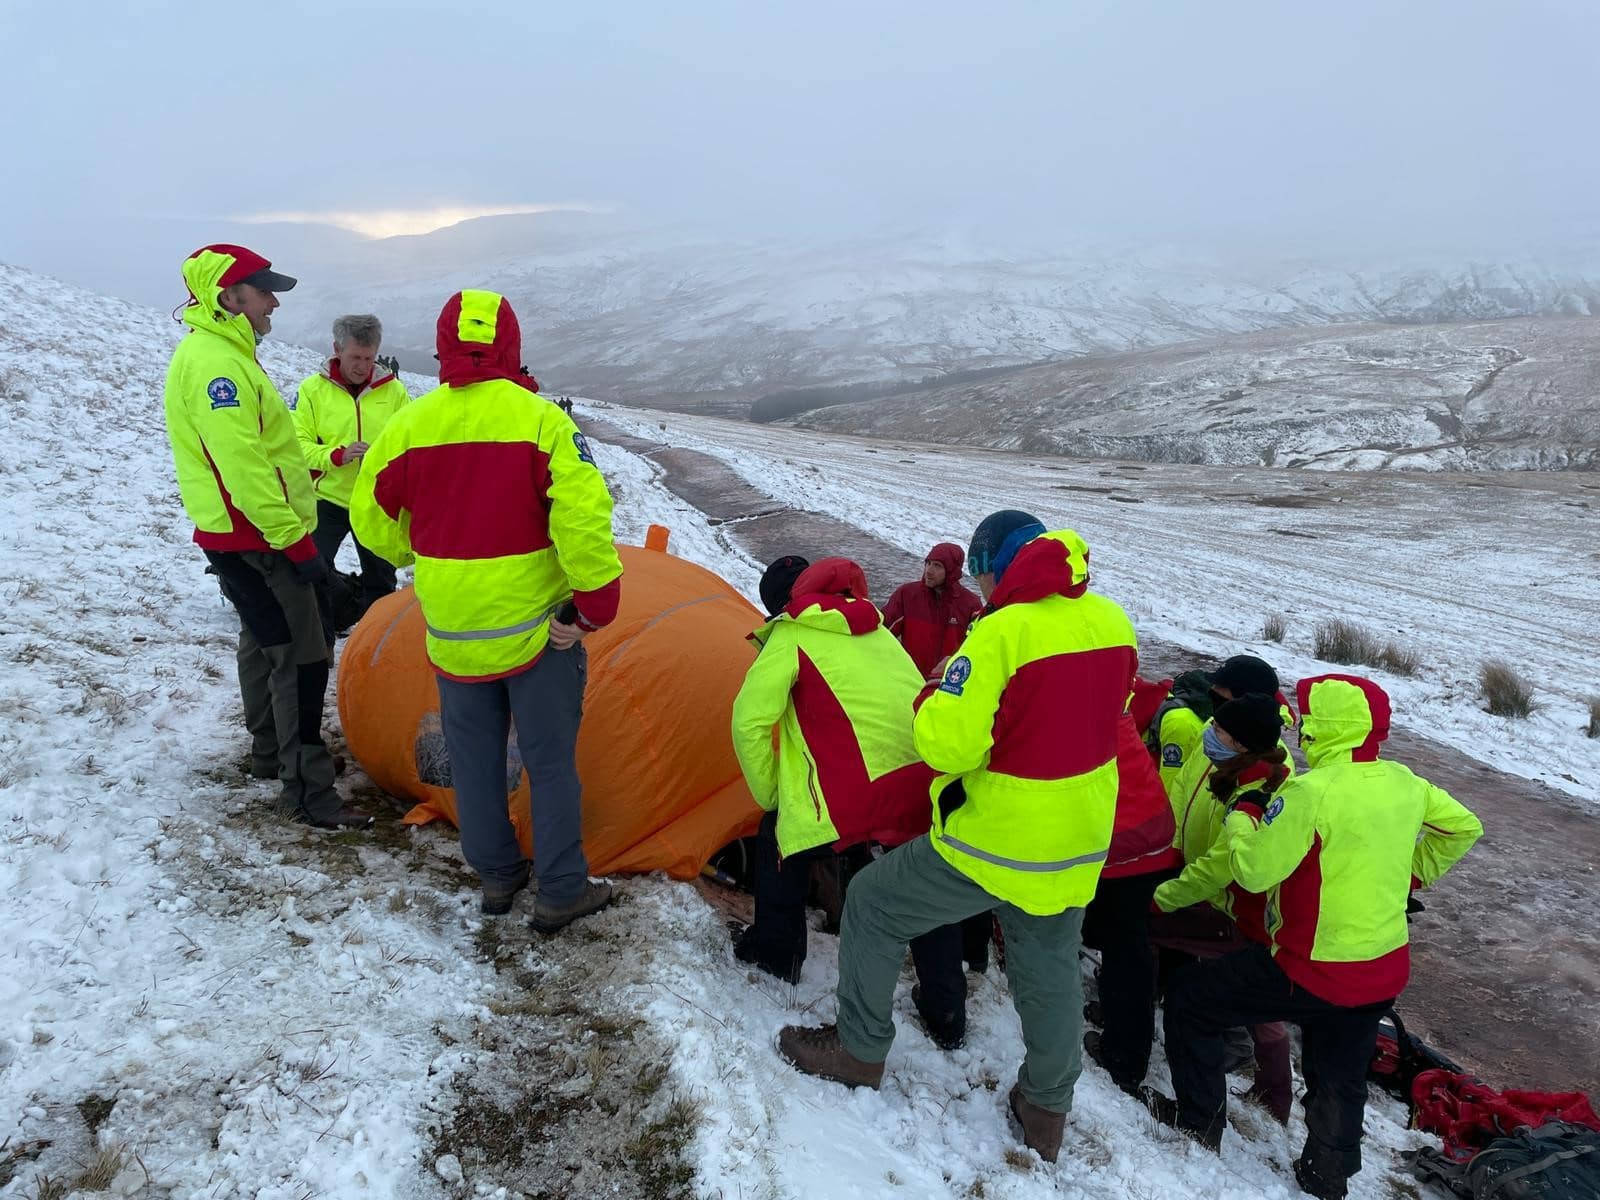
[794,317,1600,470]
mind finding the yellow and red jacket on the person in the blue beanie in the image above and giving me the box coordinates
[914,530,1138,915]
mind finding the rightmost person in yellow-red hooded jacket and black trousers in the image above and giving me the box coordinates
[1155,675,1483,1200]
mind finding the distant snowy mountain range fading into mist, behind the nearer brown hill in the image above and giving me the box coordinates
[262,213,1600,414]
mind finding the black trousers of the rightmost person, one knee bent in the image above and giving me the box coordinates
[1165,946,1392,1181]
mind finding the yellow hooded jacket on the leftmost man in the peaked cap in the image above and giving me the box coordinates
[162,250,317,562]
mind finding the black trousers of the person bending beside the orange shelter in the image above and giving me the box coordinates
[742,813,966,1013]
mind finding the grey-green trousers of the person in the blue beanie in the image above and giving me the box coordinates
[838,834,1083,1112]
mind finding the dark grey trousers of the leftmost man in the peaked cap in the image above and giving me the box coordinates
[206,550,344,819]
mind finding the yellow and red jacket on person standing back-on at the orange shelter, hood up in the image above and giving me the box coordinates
[350,291,622,682]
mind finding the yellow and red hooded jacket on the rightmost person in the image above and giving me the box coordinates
[1224,675,1483,1006]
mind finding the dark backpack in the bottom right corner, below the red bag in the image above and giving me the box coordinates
[1402,1122,1600,1200]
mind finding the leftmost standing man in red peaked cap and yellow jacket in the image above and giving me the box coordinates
[163,245,371,829]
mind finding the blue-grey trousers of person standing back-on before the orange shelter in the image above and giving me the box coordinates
[438,645,589,904]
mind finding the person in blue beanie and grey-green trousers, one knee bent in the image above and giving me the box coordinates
[778,510,1138,1162]
